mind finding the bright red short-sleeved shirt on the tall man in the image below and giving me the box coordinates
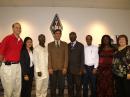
[0,34,23,62]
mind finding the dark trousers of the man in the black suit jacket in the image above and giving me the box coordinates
[67,73,82,97]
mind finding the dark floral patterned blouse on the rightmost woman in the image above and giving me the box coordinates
[112,46,130,78]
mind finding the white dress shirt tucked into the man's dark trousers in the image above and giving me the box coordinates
[84,45,99,68]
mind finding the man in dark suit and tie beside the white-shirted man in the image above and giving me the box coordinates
[67,32,84,97]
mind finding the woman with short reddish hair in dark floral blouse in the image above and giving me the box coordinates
[113,35,130,97]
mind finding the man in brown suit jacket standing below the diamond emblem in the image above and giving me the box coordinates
[48,29,68,97]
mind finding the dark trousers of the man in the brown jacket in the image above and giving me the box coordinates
[50,70,65,97]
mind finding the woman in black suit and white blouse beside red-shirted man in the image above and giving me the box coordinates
[20,37,34,97]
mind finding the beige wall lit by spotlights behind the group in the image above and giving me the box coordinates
[0,7,130,45]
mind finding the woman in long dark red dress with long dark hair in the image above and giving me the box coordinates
[97,35,115,97]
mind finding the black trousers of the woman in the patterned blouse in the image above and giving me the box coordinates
[114,76,130,97]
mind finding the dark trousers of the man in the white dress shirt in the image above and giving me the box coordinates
[83,66,96,97]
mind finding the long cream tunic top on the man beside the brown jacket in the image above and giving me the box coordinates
[33,45,48,79]
